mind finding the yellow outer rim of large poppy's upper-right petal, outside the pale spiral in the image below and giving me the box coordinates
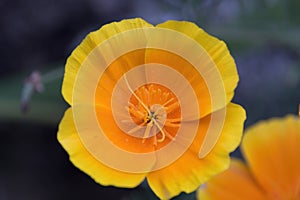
[157,20,239,113]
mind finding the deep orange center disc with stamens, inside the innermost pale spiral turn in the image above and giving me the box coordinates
[126,82,181,146]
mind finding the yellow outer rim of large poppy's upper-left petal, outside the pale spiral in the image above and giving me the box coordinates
[62,18,152,105]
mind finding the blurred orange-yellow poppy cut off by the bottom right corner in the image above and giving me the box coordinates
[198,115,300,200]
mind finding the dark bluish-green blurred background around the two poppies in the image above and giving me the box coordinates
[0,0,300,200]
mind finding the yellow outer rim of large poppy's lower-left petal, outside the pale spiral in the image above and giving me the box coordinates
[57,108,145,188]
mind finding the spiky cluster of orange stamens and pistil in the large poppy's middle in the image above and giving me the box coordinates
[122,80,181,146]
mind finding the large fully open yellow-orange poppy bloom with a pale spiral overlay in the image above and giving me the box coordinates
[58,18,245,199]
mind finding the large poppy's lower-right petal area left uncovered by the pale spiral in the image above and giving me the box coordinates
[147,104,245,199]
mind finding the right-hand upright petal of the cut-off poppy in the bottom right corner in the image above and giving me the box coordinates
[242,115,300,199]
